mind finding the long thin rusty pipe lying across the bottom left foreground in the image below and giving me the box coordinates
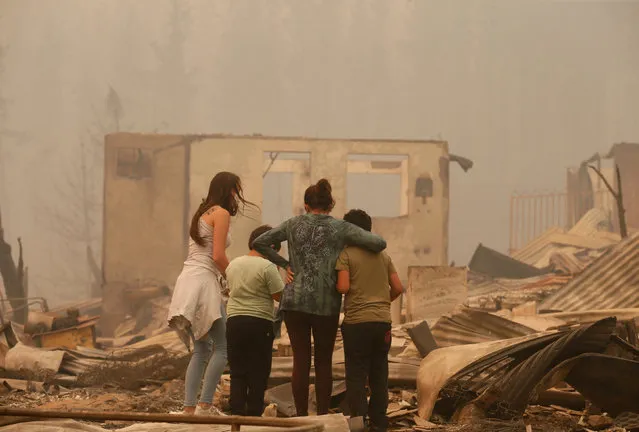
[0,407,324,432]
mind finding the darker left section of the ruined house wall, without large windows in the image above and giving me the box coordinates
[103,134,188,284]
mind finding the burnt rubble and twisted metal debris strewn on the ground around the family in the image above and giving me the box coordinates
[0,211,639,432]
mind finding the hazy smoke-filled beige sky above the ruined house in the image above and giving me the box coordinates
[0,0,639,304]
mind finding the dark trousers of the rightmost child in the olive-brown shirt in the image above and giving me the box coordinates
[342,322,391,431]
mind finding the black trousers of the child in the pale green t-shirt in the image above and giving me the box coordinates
[226,315,273,416]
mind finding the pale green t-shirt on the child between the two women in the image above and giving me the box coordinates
[226,255,284,321]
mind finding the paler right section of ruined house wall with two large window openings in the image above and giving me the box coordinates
[190,137,449,278]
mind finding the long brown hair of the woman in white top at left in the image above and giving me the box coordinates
[189,171,257,246]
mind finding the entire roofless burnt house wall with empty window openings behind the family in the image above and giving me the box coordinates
[104,134,449,284]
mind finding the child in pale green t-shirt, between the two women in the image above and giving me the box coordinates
[226,225,284,416]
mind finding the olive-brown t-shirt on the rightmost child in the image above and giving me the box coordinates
[335,246,397,324]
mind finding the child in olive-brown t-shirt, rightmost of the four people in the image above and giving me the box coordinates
[335,210,403,431]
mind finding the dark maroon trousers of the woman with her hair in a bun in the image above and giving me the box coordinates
[283,311,339,416]
